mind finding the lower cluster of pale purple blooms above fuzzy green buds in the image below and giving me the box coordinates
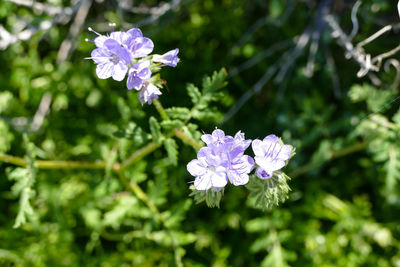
[187,129,292,190]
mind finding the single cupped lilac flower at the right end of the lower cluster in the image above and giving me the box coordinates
[251,134,292,179]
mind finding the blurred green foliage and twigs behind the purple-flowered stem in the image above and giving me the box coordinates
[0,0,400,266]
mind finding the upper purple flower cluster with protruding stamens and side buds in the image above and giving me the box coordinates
[87,25,179,105]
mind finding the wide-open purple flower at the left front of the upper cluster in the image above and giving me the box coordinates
[89,39,131,81]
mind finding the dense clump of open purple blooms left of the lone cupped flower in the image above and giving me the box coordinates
[187,129,254,190]
